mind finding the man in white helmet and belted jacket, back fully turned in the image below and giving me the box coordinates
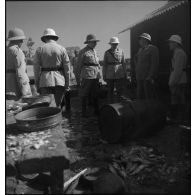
[34,28,70,109]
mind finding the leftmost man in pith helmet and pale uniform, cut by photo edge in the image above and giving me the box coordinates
[6,28,32,100]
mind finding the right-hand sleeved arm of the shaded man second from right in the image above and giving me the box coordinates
[147,48,159,79]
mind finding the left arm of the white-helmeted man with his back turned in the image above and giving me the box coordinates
[33,48,41,89]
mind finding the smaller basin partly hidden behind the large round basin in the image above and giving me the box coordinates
[22,95,51,104]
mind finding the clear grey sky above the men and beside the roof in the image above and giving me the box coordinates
[6,1,166,59]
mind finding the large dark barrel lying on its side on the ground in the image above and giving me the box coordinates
[99,99,166,143]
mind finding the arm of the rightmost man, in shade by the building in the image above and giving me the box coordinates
[169,53,185,86]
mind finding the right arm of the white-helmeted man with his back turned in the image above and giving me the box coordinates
[62,48,70,89]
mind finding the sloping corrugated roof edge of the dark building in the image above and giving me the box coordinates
[119,0,189,34]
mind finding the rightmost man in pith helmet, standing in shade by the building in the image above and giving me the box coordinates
[168,35,187,122]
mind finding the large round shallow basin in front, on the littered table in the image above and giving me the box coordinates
[15,107,62,131]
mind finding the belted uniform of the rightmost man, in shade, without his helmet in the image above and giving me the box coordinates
[169,48,187,104]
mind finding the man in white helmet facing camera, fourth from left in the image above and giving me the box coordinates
[103,37,126,101]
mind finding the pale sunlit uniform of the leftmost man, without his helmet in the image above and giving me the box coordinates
[6,44,32,100]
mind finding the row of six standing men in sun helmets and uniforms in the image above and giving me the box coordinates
[6,28,187,122]
